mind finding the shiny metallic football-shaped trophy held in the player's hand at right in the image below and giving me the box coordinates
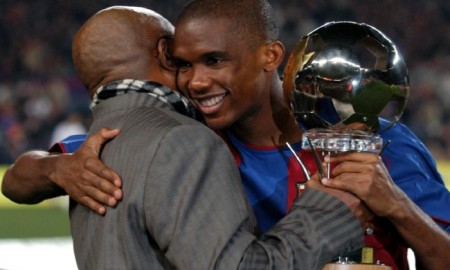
[283,21,409,269]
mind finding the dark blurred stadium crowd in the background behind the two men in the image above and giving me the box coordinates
[0,0,450,164]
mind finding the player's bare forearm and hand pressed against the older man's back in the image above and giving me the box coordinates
[2,129,122,214]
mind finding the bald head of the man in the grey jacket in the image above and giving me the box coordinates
[72,6,174,96]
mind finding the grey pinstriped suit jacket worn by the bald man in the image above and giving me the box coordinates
[70,93,363,270]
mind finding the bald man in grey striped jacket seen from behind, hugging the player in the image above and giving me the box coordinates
[1,6,362,269]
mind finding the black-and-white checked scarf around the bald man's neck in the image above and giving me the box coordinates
[90,79,202,121]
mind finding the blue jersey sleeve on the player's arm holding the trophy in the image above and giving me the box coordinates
[380,123,450,232]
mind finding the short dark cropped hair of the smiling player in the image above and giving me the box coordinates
[176,0,279,47]
